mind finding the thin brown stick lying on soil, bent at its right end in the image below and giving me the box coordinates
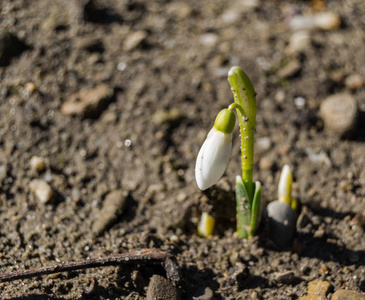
[0,249,180,284]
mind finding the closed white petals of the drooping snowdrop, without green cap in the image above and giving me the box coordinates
[195,128,232,190]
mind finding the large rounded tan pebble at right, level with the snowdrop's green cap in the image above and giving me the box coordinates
[320,94,358,137]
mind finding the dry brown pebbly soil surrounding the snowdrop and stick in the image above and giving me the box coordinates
[0,0,365,299]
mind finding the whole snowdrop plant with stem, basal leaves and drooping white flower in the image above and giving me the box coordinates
[195,67,261,238]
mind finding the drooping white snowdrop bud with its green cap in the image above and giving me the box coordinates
[195,109,236,190]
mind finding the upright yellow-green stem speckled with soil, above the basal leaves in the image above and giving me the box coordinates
[228,67,256,201]
